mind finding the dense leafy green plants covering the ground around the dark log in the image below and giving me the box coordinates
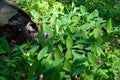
[0,0,120,80]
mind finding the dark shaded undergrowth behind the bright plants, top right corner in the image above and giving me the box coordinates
[57,0,120,26]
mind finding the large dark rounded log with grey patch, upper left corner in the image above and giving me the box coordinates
[0,0,38,46]
